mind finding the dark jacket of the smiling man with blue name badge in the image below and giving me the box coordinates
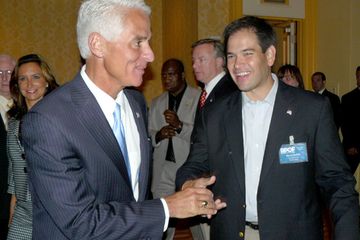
[176,81,359,240]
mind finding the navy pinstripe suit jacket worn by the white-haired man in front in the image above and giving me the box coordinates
[23,74,165,240]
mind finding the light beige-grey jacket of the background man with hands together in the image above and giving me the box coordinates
[149,86,200,197]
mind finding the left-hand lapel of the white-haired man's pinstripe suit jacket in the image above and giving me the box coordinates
[71,75,132,189]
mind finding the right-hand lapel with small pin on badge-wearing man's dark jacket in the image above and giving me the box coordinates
[258,81,297,189]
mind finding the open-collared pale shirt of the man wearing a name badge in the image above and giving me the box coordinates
[242,74,278,223]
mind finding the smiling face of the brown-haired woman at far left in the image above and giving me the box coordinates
[18,62,48,109]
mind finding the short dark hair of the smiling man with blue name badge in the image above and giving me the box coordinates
[224,16,276,54]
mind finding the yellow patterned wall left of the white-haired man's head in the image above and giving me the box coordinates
[0,0,80,83]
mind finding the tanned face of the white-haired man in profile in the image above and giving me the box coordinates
[101,9,154,93]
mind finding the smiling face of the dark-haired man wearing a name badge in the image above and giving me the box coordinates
[227,29,276,100]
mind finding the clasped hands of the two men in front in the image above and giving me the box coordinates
[165,176,226,219]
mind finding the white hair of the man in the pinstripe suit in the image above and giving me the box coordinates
[76,0,151,59]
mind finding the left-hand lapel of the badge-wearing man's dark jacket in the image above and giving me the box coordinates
[223,91,245,193]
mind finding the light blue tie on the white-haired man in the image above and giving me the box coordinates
[113,103,131,181]
